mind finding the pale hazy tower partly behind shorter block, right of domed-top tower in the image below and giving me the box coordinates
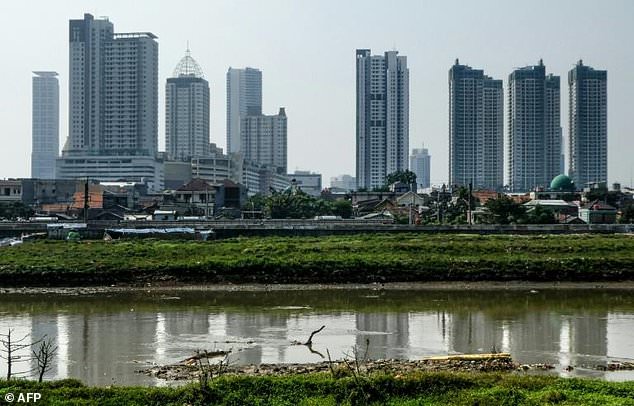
[227,68,262,154]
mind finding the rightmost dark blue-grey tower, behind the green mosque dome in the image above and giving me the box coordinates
[568,61,608,187]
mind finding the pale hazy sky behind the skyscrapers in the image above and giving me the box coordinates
[0,0,634,186]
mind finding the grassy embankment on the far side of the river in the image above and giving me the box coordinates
[0,234,634,286]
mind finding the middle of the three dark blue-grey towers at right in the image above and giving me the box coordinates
[508,60,561,192]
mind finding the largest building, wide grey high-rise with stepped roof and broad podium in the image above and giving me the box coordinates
[57,14,162,190]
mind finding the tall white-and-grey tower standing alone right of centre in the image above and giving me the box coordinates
[356,49,409,189]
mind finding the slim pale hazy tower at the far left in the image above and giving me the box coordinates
[31,72,59,179]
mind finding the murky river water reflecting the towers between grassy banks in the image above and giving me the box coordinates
[0,289,634,385]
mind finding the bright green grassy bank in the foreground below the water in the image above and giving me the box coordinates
[0,373,634,406]
